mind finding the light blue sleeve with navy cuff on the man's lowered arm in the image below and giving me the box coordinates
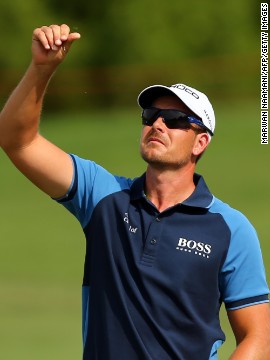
[212,203,269,310]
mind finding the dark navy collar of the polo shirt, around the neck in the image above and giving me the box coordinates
[131,173,214,209]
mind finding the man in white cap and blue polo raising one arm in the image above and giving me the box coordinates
[0,25,270,360]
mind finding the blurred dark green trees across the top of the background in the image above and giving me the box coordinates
[0,0,259,107]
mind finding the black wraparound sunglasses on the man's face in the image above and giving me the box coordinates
[142,107,213,135]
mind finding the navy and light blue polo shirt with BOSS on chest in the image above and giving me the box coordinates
[58,155,269,360]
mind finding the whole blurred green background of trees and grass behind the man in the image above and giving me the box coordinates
[0,0,270,360]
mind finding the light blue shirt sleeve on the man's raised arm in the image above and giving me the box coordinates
[57,155,132,228]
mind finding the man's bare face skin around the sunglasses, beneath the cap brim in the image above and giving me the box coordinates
[140,96,206,169]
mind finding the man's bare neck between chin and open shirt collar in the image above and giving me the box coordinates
[145,165,195,212]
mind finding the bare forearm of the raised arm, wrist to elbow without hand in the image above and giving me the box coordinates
[0,63,54,151]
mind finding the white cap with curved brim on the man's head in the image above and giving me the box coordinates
[138,84,215,135]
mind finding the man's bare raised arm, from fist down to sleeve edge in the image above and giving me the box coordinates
[0,25,80,198]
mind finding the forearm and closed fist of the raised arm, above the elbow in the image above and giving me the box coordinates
[0,24,80,154]
